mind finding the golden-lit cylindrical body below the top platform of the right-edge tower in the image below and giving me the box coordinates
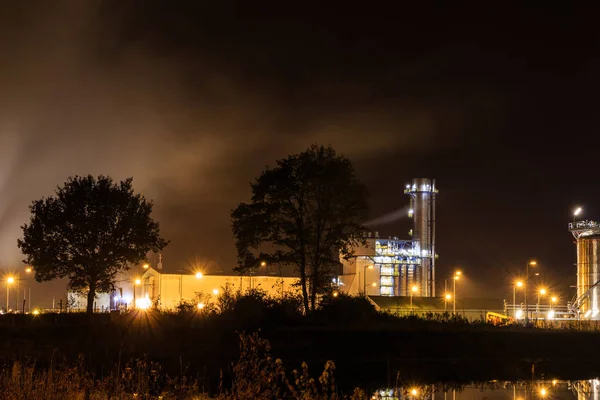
[577,235,600,319]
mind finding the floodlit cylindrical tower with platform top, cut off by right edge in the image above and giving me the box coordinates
[569,221,600,320]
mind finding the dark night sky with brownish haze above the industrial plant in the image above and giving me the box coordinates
[0,0,600,305]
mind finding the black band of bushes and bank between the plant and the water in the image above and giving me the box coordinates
[0,291,600,398]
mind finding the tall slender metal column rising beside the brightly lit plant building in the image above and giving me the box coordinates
[404,178,437,297]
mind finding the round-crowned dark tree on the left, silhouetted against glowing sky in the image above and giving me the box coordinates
[18,175,167,314]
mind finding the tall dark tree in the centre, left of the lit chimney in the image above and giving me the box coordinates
[231,145,368,312]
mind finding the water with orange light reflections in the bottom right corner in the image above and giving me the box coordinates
[371,379,600,400]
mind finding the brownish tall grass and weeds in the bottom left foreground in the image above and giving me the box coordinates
[0,333,366,400]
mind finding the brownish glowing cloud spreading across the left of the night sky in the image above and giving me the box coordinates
[0,1,458,276]
